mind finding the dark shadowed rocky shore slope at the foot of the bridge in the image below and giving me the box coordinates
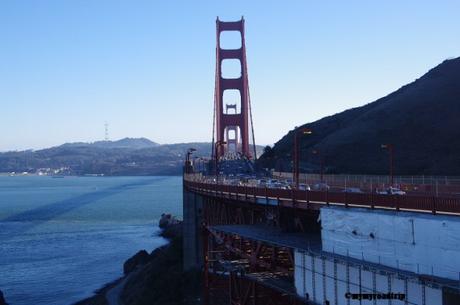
[72,218,201,305]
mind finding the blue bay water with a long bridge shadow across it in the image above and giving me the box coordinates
[0,176,182,305]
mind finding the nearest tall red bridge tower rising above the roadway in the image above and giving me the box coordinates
[212,18,255,159]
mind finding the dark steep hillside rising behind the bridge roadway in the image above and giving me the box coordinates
[259,58,460,175]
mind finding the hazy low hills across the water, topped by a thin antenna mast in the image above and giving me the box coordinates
[0,138,262,176]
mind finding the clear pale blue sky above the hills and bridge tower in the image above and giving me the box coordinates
[0,0,460,151]
